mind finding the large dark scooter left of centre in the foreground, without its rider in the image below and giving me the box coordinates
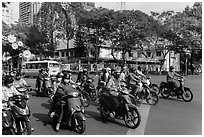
[53,91,86,134]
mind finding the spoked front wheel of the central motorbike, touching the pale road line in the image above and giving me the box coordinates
[124,108,141,129]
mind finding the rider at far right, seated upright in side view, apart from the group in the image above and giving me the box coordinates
[166,66,183,94]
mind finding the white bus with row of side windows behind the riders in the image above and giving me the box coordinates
[21,60,61,77]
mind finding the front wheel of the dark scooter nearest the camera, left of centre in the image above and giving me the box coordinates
[73,118,86,134]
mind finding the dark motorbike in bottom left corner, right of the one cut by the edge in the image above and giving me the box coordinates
[9,95,31,135]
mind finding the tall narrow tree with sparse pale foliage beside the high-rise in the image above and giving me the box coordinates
[36,2,66,56]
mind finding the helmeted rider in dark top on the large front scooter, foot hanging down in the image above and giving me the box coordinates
[49,73,75,131]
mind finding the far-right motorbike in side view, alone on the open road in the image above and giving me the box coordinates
[160,78,193,102]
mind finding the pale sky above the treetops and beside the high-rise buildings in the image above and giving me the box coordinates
[9,0,194,21]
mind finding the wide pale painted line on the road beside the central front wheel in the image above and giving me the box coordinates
[127,104,151,135]
